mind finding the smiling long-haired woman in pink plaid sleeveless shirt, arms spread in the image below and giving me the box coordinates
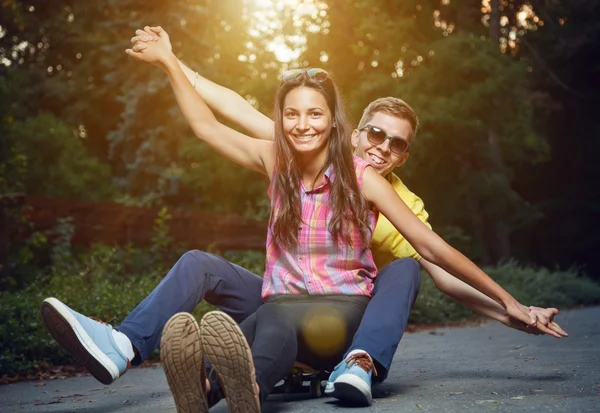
[127,40,535,411]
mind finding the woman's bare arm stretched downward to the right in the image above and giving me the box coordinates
[363,168,549,333]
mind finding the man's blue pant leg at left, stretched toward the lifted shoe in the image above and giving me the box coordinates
[117,250,263,364]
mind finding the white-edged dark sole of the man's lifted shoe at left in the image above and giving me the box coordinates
[40,298,119,384]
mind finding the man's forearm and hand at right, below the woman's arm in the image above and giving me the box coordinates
[419,258,567,338]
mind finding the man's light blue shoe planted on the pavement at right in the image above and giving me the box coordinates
[325,352,377,406]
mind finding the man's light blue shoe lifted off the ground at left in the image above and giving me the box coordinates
[40,298,130,384]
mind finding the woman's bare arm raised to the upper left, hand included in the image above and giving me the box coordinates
[126,31,274,175]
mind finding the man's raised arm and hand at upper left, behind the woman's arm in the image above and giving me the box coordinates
[131,26,273,140]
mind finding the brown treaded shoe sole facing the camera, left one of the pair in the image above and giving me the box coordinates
[160,313,208,413]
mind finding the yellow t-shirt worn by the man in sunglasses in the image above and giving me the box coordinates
[371,173,431,270]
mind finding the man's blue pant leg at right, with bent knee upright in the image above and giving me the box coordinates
[344,258,421,382]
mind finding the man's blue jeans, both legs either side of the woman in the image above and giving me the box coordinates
[117,250,420,381]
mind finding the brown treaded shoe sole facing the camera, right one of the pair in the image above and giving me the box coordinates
[201,311,260,413]
